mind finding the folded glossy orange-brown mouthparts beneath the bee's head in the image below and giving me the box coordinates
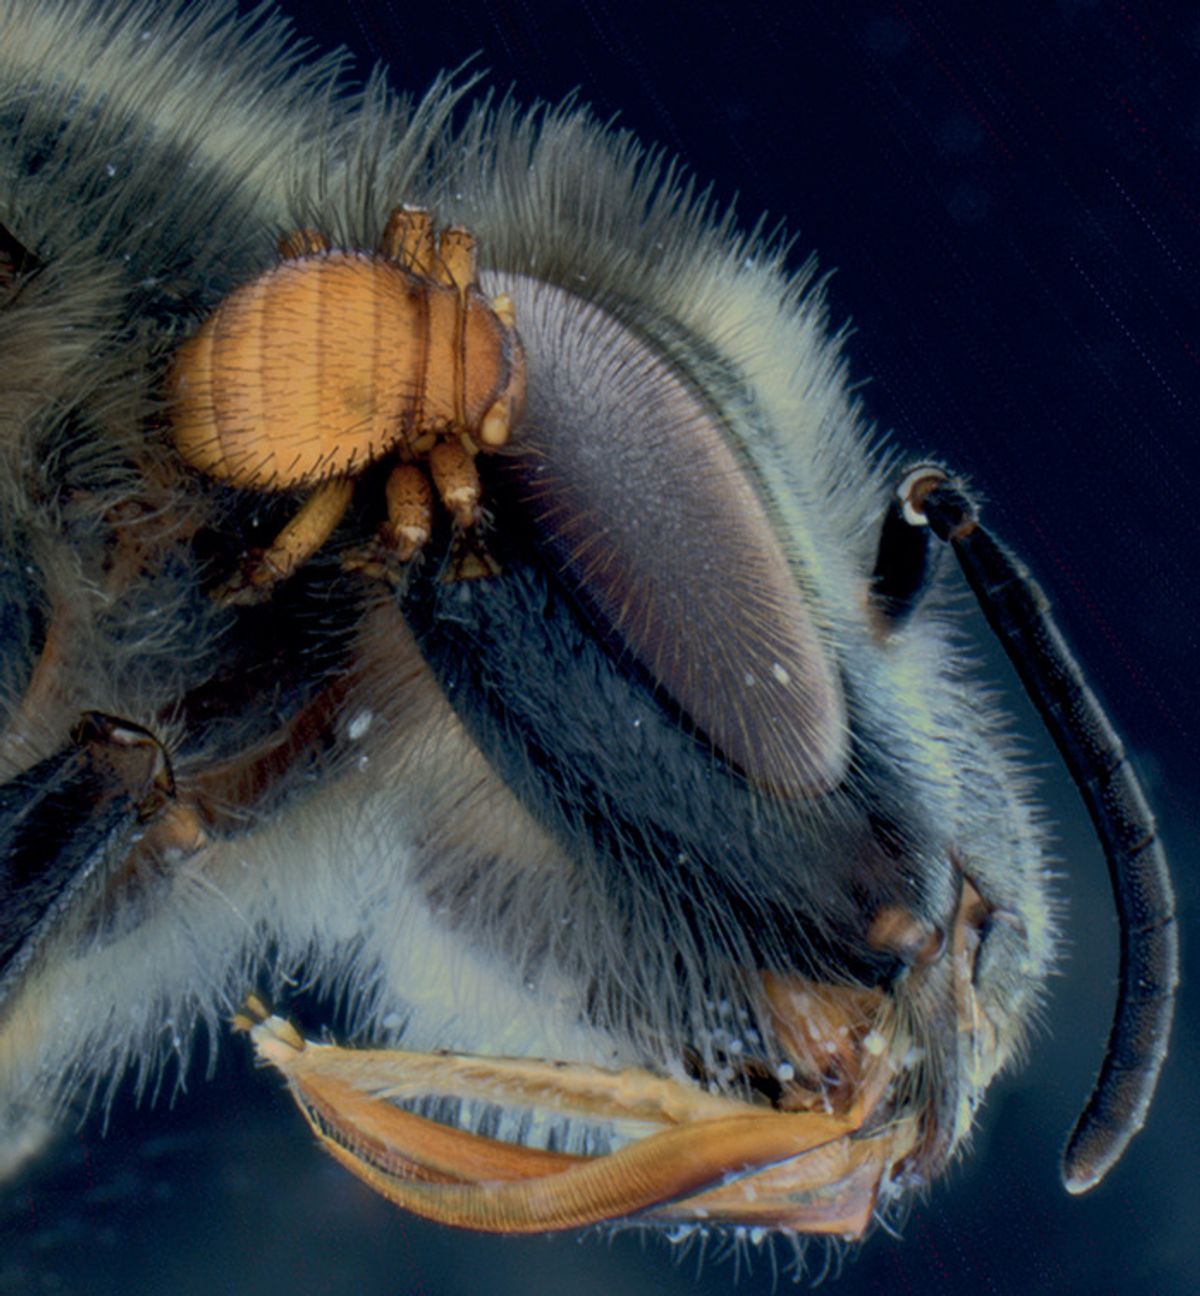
[240,1003,919,1238]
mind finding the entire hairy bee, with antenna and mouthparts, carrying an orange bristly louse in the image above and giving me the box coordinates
[0,0,1175,1275]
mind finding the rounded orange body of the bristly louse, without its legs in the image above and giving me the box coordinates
[168,251,524,490]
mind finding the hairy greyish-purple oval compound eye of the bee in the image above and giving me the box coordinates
[489,276,846,797]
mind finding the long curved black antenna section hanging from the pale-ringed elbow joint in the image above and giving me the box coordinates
[898,467,1179,1194]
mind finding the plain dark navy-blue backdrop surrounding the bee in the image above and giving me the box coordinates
[0,0,1200,1296]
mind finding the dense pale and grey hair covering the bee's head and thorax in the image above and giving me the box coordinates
[0,0,1054,1254]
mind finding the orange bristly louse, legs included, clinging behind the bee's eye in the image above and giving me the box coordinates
[168,207,525,600]
